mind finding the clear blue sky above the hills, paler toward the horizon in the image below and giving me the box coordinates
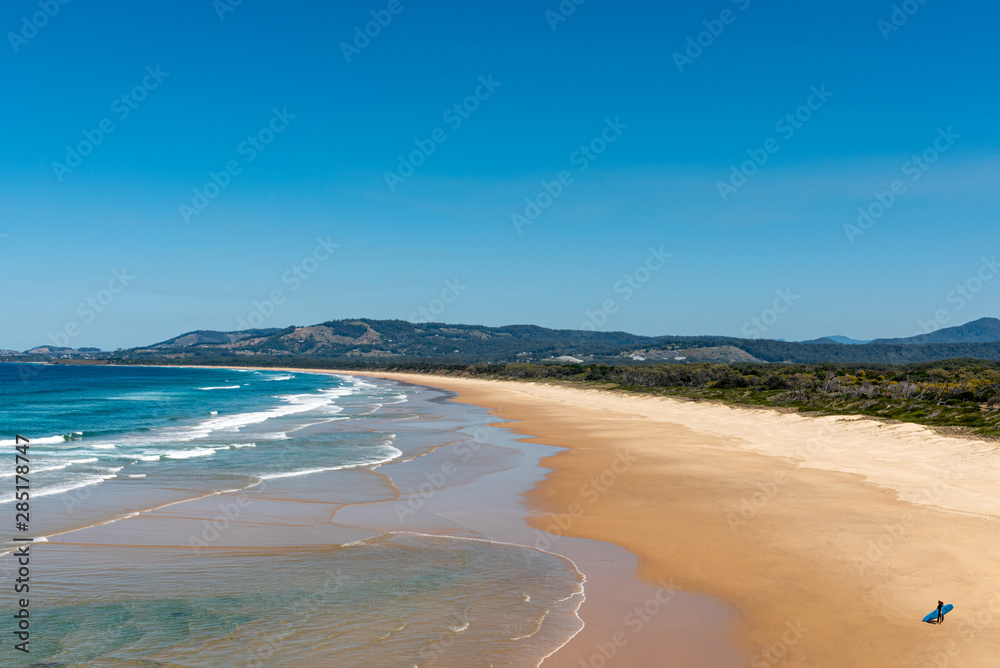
[0,0,1000,349]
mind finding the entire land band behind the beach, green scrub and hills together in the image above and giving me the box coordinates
[21,318,1000,436]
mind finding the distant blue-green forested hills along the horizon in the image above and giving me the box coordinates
[13,318,1000,367]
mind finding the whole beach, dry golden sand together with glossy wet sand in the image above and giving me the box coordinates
[27,362,1000,668]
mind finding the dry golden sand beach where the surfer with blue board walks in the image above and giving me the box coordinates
[330,373,1000,667]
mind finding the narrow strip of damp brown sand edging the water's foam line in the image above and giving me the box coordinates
[145,365,750,668]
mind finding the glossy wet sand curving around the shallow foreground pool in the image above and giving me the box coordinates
[29,374,744,668]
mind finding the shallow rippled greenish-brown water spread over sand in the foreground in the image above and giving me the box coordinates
[13,534,581,668]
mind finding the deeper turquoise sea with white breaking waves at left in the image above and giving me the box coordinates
[0,364,404,503]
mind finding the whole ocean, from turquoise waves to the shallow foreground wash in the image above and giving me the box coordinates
[0,364,584,668]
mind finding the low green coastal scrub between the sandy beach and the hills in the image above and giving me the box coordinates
[97,356,1000,438]
